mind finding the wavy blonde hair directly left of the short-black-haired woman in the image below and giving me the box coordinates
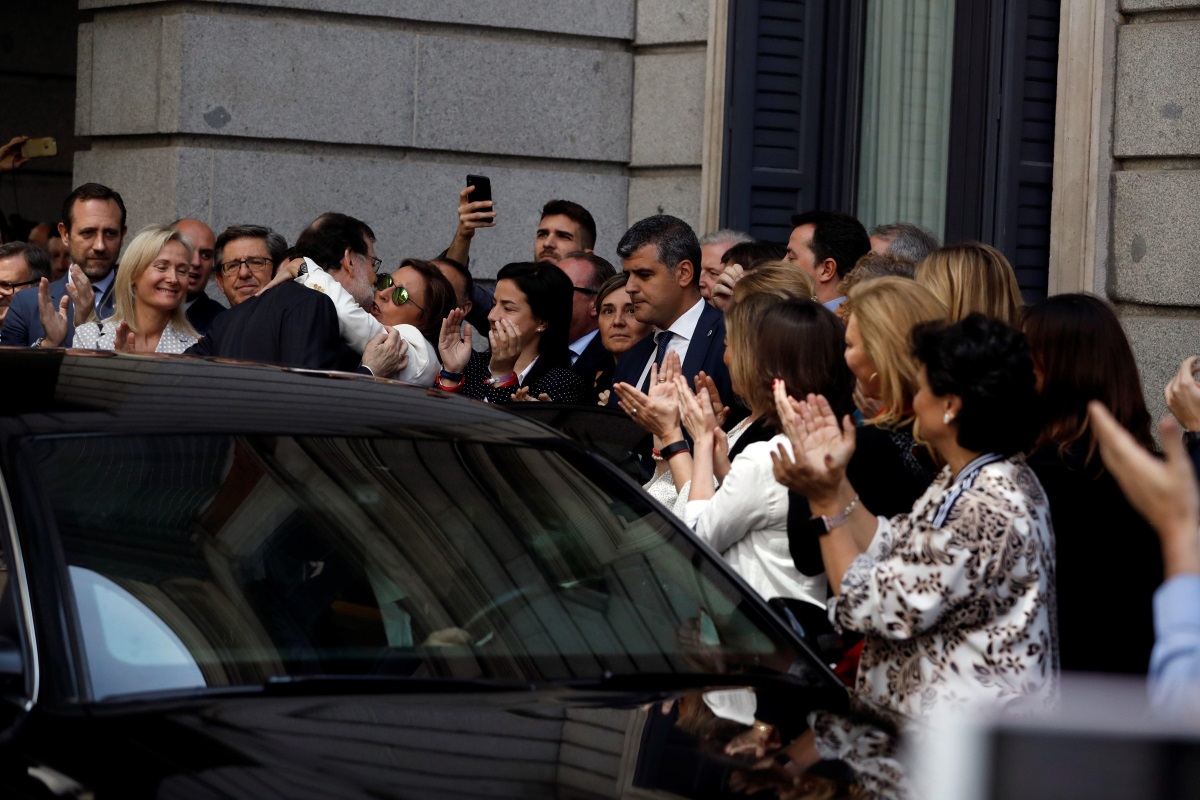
[848,277,946,426]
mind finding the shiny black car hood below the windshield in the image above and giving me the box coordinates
[16,691,787,799]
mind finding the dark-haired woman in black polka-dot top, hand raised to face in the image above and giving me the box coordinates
[436,261,588,403]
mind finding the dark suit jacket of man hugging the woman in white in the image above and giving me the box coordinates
[187,281,358,371]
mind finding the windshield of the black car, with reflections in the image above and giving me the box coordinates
[25,433,828,699]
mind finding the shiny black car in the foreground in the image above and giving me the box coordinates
[0,349,878,799]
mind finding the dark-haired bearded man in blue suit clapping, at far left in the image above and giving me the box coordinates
[0,184,125,347]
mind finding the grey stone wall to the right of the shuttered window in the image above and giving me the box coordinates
[1097,0,1200,419]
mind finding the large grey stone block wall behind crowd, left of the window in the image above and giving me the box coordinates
[74,0,638,276]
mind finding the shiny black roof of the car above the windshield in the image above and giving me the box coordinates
[0,348,560,444]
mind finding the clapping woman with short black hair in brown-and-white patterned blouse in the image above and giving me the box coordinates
[774,314,1058,717]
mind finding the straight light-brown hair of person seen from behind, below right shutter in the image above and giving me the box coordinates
[917,242,1021,329]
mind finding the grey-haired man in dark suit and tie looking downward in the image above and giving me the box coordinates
[608,215,745,421]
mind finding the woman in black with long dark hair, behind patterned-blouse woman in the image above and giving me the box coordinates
[1025,294,1163,675]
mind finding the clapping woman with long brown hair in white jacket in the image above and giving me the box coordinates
[664,294,854,606]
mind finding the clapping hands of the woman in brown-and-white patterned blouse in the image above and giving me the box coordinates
[770,380,854,503]
